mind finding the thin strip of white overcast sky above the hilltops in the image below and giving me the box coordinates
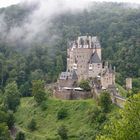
[0,0,140,7]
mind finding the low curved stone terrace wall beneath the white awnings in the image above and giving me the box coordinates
[53,89,93,100]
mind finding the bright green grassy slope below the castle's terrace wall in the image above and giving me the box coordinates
[15,97,96,140]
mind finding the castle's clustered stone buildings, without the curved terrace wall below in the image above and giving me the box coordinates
[59,36,115,89]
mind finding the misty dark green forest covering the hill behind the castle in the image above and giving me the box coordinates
[0,3,140,87]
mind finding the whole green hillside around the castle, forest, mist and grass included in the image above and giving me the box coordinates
[0,3,140,140]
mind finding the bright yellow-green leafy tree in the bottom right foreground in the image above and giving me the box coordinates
[97,94,140,140]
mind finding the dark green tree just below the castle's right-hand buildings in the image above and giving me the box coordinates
[99,92,112,113]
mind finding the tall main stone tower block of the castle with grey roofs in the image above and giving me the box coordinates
[67,36,102,79]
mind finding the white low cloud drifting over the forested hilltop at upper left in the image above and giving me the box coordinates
[0,0,93,45]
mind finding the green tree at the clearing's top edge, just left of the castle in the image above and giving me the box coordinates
[32,80,46,104]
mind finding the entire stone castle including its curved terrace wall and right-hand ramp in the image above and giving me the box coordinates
[54,36,125,107]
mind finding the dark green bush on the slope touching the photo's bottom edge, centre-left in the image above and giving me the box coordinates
[57,125,68,140]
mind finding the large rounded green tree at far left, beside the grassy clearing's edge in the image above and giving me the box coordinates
[4,82,20,111]
